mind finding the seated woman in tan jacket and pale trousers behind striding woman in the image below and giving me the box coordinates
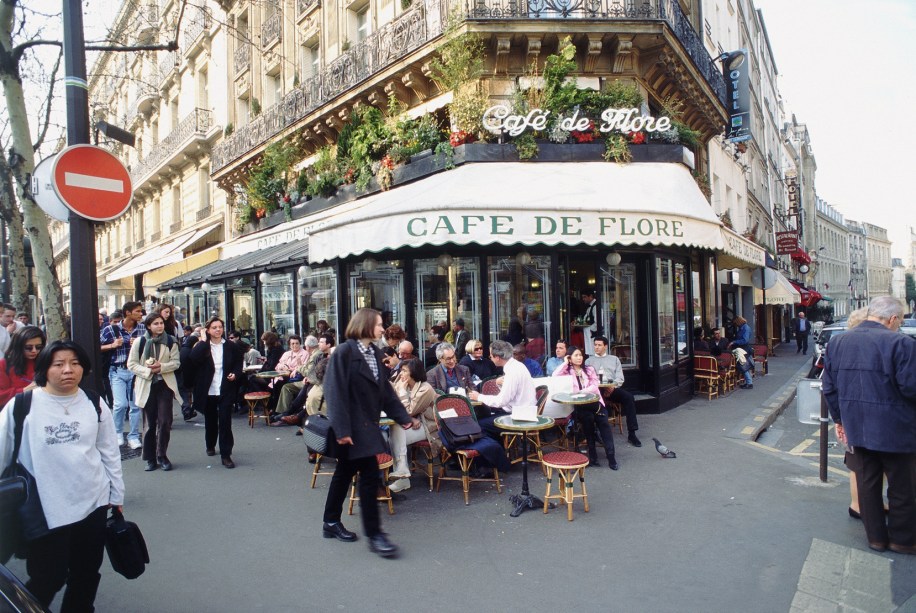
[389,360,441,492]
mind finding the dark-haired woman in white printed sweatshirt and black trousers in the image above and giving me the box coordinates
[0,341,124,611]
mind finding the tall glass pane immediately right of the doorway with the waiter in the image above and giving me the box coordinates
[598,264,639,366]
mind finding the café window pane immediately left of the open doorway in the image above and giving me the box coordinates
[487,252,553,362]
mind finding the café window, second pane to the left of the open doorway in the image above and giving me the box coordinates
[414,256,483,355]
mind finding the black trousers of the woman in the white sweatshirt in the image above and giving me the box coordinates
[25,506,108,613]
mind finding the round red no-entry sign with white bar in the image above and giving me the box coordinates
[51,145,133,221]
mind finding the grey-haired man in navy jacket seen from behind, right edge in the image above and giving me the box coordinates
[823,296,916,555]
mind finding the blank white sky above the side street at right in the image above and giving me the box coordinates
[755,0,916,258]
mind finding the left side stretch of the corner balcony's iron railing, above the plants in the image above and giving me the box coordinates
[210,0,449,172]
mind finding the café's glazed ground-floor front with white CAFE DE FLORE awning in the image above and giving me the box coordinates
[162,144,765,412]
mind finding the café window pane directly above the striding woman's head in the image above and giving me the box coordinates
[347,258,406,328]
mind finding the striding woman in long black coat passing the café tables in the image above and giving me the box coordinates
[322,309,417,557]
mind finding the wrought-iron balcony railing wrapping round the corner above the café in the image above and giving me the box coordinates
[211,0,725,173]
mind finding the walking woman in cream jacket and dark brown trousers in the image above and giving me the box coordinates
[127,313,181,472]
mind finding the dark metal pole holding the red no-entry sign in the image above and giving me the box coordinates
[63,0,101,390]
